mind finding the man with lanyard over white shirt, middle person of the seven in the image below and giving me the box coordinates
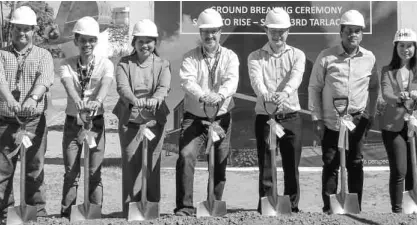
[174,8,239,216]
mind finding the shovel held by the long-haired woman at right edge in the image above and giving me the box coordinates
[403,100,417,214]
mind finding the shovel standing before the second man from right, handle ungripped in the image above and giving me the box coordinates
[330,98,360,214]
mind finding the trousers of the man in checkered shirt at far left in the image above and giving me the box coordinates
[0,114,48,217]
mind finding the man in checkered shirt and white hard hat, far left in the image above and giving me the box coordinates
[0,6,54,218]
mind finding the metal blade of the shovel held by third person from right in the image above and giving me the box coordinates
[261,195,291,216]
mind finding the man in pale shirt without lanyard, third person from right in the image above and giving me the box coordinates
[248,8,306,212]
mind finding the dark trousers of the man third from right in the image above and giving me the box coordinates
[255,113,302,211]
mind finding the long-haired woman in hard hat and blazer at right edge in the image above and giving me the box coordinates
[380,28,417,213]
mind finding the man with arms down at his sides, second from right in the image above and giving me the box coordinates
[308,10,379,213]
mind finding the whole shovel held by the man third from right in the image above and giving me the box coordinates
[261,102,291,216]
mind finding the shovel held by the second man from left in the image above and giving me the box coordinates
[70,111,101,222]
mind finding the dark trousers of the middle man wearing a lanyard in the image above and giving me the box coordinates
[174,112,232,215]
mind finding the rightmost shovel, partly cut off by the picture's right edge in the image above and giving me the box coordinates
[403,99,417,214]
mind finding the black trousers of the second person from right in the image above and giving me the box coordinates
[321,114,369,211]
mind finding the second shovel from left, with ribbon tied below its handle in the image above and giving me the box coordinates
[70,110,101,222]
